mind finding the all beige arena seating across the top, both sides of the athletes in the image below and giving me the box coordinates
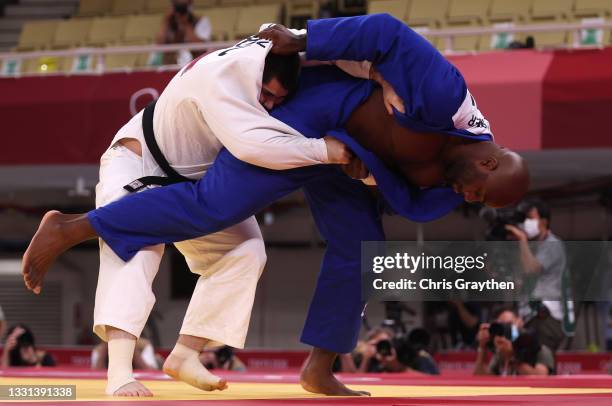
[1,0,612,72]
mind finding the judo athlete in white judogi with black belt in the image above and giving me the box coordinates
[94,38,350,396]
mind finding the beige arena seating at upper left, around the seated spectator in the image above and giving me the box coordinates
[5,0,298,73]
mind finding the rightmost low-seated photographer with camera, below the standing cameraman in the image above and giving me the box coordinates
[474,310,555,376]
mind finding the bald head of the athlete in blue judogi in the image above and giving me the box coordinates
[445,142,529,207]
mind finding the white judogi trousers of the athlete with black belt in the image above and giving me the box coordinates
[94,144,266,348]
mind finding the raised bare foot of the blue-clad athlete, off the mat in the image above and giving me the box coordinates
[21,210,95,294]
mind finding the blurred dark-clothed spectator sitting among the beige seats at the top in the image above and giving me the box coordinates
[157,0,212,65]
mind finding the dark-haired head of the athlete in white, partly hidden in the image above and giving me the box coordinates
[259,53,300,110]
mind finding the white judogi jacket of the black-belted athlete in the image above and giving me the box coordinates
[113,39,328,179]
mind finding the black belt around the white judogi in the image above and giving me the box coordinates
[123,101,195,193]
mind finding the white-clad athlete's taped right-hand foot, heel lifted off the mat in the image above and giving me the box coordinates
[163,353,227,391]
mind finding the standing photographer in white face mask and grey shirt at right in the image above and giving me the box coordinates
[506,201,573,351]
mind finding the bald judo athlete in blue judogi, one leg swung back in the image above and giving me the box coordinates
[26,15,528,394]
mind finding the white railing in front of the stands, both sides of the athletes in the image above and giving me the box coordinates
[0,21,612,74]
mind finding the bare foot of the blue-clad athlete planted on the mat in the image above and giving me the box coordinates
[300,348,370,396]
